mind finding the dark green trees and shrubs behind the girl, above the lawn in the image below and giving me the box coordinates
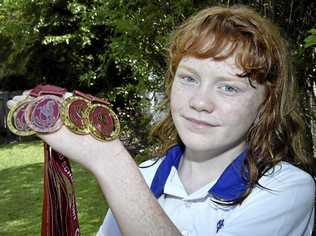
[0,0,316,157]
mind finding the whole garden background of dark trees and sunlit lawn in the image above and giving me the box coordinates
[0,0,316,235]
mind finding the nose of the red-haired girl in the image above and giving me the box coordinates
[189,89,215,113]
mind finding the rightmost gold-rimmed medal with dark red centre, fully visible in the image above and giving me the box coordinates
[86,104,120,141]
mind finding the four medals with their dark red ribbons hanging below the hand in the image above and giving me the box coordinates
[7,85,120,236]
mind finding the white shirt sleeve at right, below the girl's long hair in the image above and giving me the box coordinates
[216,164,315,236]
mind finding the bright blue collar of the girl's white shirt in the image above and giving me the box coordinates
[150,145,247,202]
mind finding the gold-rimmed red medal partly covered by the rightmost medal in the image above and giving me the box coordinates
[61,96,90,134]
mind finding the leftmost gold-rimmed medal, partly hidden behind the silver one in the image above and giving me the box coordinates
[7,99,35,136]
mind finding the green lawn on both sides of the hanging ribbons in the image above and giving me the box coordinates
[0,141,107,236]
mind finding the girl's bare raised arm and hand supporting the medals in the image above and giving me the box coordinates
[40,127,180,235]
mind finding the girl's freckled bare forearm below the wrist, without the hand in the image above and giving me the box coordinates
[95,149,181,236]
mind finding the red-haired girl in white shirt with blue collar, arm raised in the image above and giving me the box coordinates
[8,3,315,236]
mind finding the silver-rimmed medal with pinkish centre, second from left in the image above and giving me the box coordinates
[26,95,62,133]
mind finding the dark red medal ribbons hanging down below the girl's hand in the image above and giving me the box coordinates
[41,143,80,236]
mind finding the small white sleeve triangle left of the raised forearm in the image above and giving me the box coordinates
[97,209,121,236]
